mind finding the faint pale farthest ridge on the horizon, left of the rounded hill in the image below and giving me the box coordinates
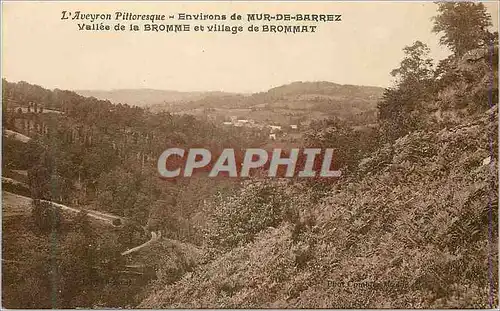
[75,89,235,107]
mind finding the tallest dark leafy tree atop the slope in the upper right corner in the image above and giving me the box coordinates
[432,2,494,56]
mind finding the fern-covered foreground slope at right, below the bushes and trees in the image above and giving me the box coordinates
[140,107,498,308]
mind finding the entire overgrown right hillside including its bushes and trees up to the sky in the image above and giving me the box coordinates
[141,3,498,309]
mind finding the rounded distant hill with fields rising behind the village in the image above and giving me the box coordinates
[147,81,384,124]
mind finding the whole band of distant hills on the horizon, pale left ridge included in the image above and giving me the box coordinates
[76,81,384,125]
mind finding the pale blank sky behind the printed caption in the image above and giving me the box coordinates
[2,1,498,93]
